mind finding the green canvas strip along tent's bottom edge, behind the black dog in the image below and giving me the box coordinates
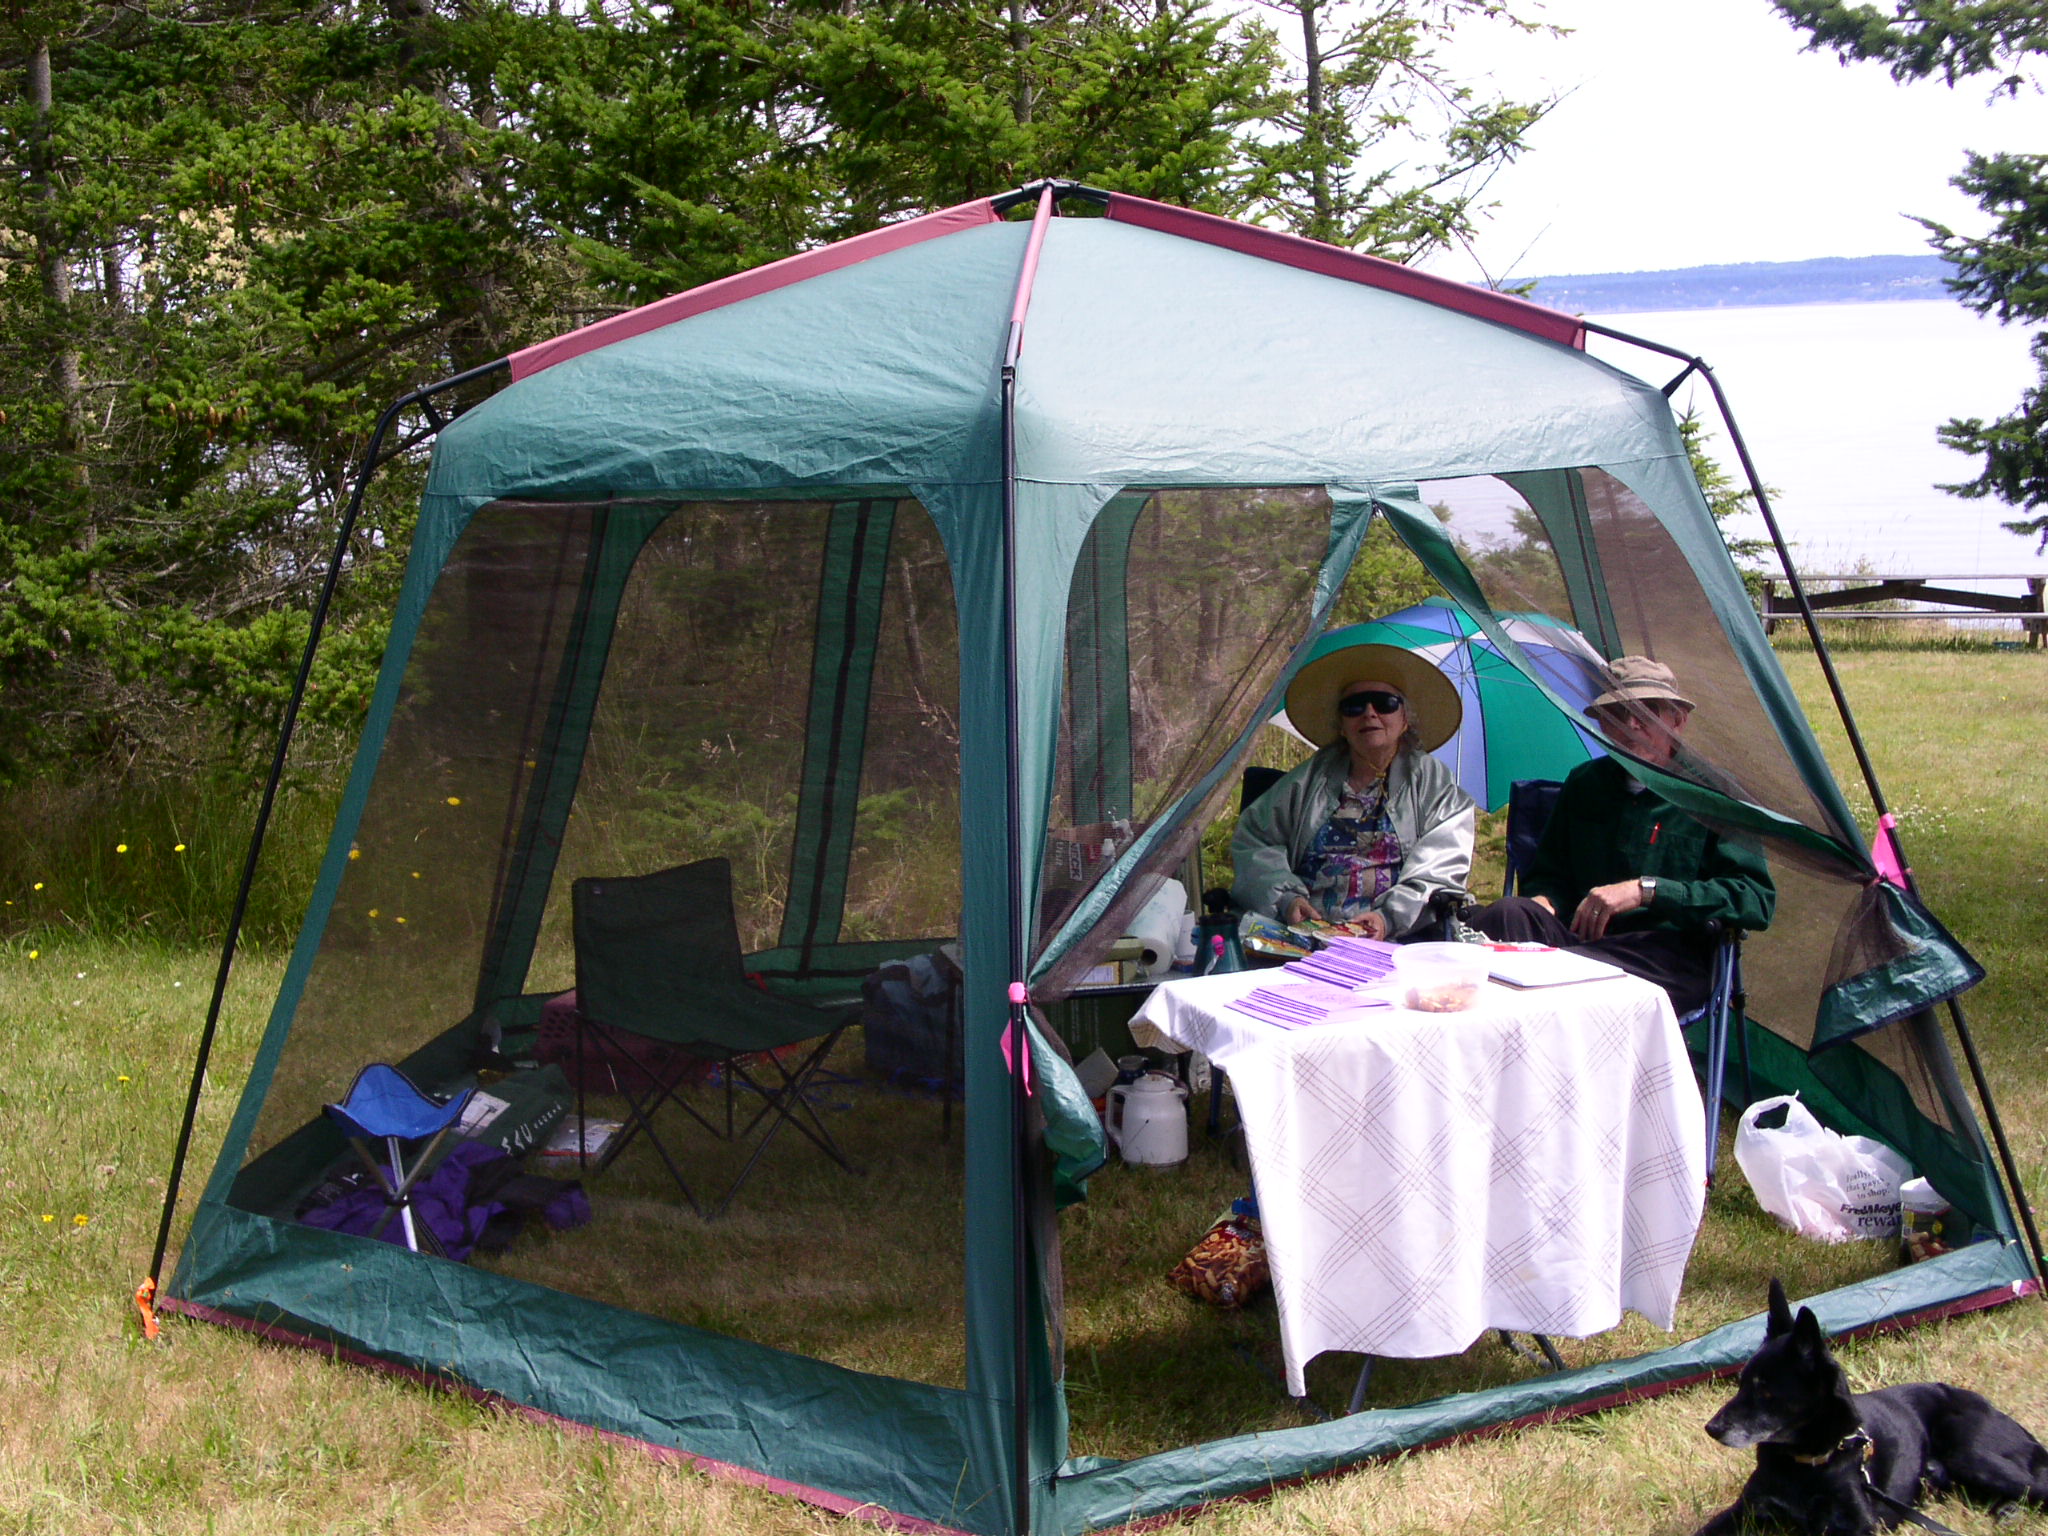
[1055,1241,2032,1536]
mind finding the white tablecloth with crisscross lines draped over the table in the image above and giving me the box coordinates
[1130,971,1706,1395]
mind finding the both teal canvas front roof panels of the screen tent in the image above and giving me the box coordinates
[428,219,1681,506]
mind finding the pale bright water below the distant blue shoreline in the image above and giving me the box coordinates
[1587,301,2048,592]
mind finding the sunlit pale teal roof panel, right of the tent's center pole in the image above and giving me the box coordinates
[1018,219,1683,485]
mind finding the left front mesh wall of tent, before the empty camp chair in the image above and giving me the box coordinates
[236,500,965,1386]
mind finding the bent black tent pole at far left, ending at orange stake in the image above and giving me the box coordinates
[137,358,510,1311]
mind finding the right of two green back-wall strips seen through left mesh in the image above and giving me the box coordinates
[782,500,895,956]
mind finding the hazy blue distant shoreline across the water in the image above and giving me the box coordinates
[1528,254,1952,315]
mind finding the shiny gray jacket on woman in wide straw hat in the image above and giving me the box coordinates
[1231,741,1477,938]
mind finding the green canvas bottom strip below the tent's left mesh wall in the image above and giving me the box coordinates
[176,1202,1008,1532]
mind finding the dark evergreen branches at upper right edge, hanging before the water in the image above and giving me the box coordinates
[1772,0,2048,549]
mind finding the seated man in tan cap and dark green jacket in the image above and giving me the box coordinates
[1466,655,1778,1014]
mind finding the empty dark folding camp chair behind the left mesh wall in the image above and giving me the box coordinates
[569,858,858,1217]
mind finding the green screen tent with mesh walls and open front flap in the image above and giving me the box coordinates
[166,186,2032,1532]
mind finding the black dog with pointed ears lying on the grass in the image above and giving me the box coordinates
[1700,1280,2048,1536]
